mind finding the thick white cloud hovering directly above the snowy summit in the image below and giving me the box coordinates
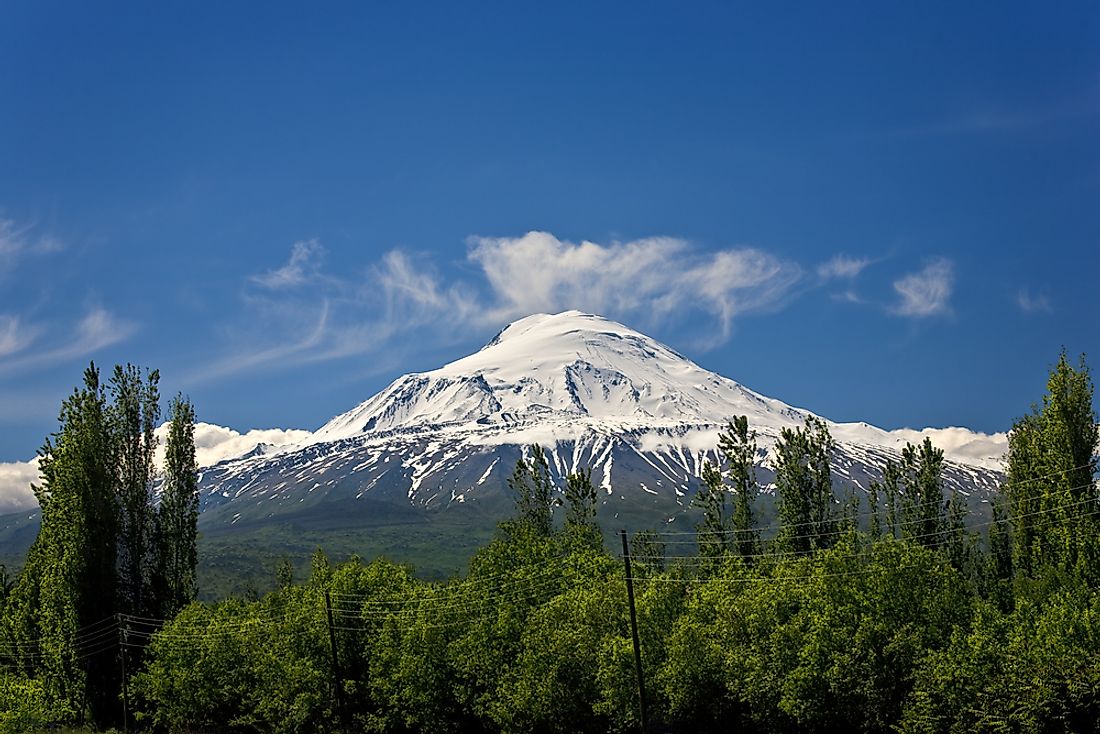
[469,232,802,340]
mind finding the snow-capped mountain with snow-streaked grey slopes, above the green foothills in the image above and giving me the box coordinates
[201,311,1007,525]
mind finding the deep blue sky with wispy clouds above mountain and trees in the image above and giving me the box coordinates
[0,0,1100,461]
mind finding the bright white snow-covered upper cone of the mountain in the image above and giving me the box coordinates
[308,310,1003,465]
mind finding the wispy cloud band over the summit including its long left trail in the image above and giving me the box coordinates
[206,232,802,381]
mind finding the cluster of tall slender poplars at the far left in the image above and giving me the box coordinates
[0,364,198,731]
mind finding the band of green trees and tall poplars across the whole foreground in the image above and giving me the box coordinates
[0,354,1100,733]
